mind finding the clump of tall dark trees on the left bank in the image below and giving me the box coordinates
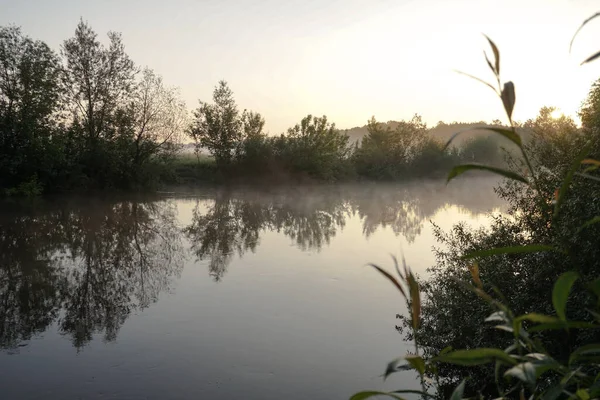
[0,21,187,195]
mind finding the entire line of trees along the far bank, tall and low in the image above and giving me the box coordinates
[0,21,516,195]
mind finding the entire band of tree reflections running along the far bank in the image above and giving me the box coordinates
[0,181,502,349]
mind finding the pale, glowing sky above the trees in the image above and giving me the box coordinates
[0,0,600,134]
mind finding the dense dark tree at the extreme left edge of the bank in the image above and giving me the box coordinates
[0,27,61,191]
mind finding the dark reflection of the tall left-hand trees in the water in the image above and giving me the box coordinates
[0,201,183,348]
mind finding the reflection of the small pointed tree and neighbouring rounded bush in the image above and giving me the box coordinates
[184,190,349,282]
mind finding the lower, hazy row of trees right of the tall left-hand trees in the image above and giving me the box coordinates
[184,81,516,181]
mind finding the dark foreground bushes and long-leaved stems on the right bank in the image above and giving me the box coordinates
[353,22,600,399]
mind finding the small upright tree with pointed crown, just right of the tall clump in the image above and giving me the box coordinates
[188,81,244,166]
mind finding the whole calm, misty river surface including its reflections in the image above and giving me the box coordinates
[0,179,503,400]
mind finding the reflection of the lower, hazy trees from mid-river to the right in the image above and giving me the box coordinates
[184,179,504,282]
